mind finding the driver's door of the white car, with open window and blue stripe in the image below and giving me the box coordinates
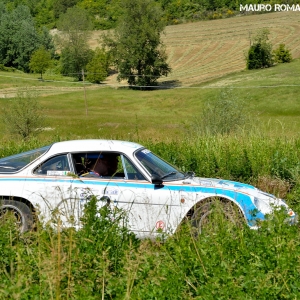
[73,152,170,236]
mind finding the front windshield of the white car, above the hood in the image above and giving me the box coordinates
[135,149,185,181]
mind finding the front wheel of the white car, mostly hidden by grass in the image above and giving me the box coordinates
[191,198,245,236]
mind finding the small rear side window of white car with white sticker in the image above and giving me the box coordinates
[33,154,70,176]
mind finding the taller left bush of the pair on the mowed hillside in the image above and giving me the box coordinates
[247,28,273,70]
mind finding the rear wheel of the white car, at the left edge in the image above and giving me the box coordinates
[0,200,34,232]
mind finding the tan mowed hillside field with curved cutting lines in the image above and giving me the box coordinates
[90,12,300,86]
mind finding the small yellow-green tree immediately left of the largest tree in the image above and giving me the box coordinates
[86,48,109,83]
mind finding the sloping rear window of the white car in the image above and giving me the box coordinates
[0,146,51,173]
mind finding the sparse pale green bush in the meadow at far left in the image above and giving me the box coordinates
[2,89,44,140]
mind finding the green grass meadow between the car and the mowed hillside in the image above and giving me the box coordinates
[0,60,300,140]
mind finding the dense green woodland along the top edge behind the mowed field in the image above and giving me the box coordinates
[2,0,297,29]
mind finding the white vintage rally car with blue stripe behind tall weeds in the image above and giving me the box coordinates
[0,140,295,237]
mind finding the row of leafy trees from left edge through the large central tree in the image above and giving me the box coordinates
[0,0,171,86]
